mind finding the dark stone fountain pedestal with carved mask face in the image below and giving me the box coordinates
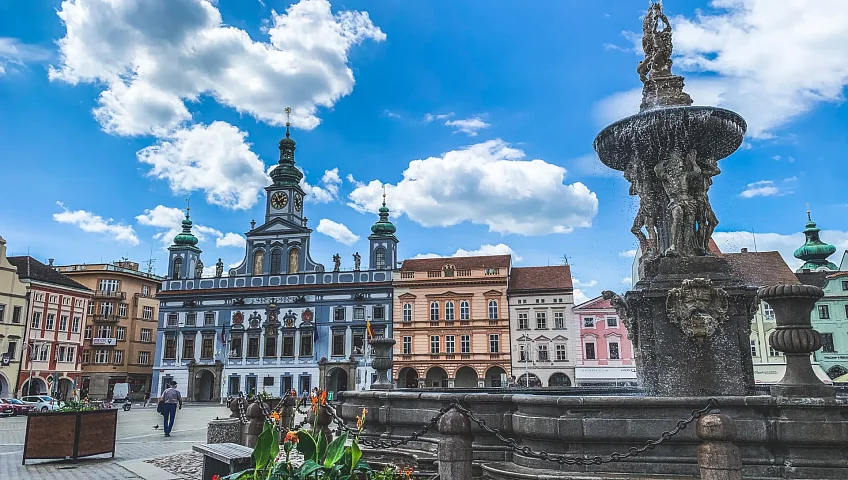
[625,256,756,397]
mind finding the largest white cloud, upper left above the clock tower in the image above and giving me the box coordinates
[50,0,386,135]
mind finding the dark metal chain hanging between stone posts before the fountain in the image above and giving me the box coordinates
[326,398,718,466]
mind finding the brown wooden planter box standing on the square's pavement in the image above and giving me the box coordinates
[21,409,118,465]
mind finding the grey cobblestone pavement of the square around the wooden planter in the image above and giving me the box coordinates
[0,404,230,480]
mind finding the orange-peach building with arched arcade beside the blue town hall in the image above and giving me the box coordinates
[392,255,511,388]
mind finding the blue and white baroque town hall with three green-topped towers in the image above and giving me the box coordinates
[153,117,398,401]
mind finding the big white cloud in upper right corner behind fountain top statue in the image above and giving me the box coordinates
[602,0,848,138]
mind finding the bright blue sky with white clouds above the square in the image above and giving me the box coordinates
[0,0,848,297]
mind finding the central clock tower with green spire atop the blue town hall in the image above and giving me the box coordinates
[265,107,305,227]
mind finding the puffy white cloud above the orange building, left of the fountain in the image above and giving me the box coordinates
[348,139,598,235]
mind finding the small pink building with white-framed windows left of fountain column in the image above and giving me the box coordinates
[573,297,636,386]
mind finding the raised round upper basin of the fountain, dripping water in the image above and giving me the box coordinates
[594,106,748,171]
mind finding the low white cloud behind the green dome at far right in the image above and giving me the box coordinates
[713,229,848,270]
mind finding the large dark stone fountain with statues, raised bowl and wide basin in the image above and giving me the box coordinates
[338,4,848,480]
